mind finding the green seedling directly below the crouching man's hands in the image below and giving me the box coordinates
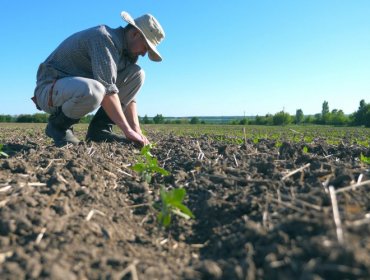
[132,144,170,183]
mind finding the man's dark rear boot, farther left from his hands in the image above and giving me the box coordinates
[45,107,80,147]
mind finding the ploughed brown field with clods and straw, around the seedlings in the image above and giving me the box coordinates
[0,124,370,280]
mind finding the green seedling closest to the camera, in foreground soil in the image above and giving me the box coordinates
[157,187,195,227]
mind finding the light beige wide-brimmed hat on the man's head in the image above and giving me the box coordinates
[121,11,164,61]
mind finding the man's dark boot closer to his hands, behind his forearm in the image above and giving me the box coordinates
[86,107,129,143]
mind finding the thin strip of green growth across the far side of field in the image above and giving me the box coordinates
[0,123,370,147]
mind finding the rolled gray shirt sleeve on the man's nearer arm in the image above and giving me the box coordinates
[88,33,119,94]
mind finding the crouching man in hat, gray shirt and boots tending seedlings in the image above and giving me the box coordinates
[32,12,164,147]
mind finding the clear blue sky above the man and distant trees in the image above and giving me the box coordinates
[0,0,370,117]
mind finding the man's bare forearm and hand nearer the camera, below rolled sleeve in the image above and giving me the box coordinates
[101,94,147,145]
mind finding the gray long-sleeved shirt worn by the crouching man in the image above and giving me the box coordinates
[35,25,131,94]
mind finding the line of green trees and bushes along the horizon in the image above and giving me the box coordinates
[0,100,370,127]
